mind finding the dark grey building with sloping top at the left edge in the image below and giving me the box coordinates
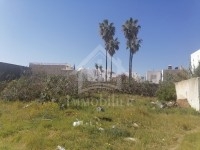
[0,62,28,81]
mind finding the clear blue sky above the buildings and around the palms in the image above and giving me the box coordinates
[0,0,200,75]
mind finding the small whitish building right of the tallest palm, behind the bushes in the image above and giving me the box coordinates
[146,71,162,84]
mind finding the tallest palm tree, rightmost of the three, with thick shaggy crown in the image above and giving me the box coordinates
[122,18,142,84]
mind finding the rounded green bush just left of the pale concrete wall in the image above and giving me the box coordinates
[156,82,176,101]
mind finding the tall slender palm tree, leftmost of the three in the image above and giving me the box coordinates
[99,19,115,82]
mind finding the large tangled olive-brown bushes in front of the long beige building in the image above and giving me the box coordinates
[0,74,78,101]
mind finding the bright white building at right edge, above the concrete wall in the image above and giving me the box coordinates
[191,49,200,71]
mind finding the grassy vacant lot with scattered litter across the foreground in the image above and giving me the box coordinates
[0,93,200,150]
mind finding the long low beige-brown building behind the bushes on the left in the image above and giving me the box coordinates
[29,63,74,75]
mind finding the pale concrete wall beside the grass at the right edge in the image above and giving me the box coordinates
[175,78,200,111]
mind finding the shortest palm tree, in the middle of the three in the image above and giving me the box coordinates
[107,38,119,79]
